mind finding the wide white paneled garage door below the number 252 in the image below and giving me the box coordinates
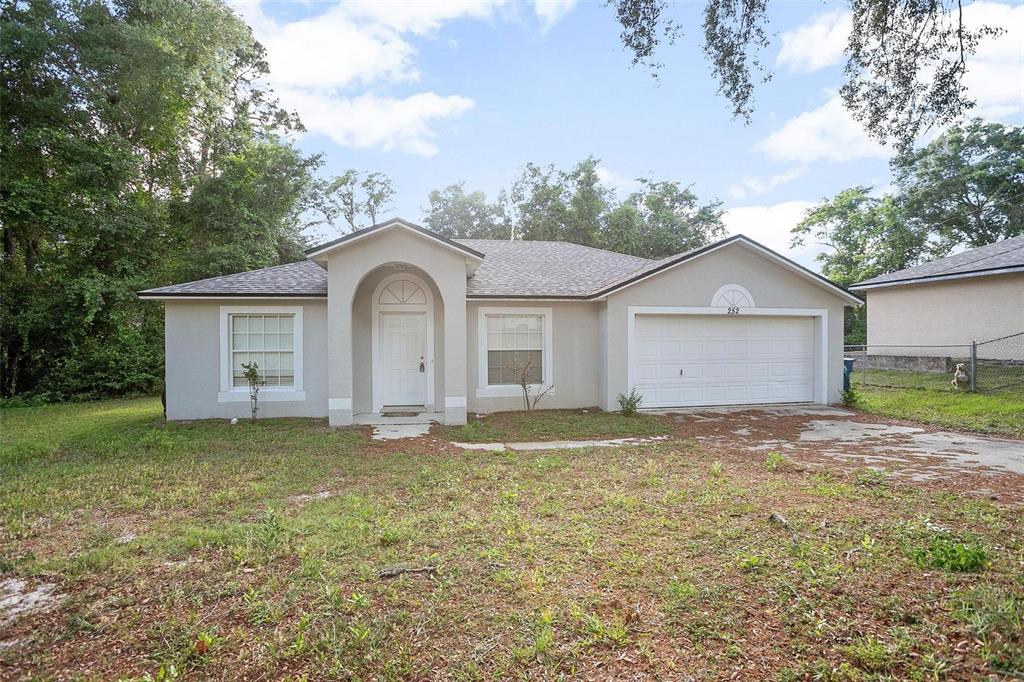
[633,314,814,408]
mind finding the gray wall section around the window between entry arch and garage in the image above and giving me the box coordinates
[466,300,604,413]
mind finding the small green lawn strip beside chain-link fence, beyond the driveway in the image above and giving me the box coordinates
[853,368,1024,438]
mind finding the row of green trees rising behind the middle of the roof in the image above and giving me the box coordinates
[424,157,725,258]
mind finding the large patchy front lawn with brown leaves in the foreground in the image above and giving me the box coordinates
[0,399,1024,680]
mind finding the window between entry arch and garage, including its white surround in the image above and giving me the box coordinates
[477,308,552,395]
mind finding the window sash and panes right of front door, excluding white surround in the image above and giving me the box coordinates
[486,314,545,386]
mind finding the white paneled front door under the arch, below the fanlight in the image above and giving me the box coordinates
[380,312,427,406]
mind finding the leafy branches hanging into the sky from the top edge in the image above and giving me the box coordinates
[606,0,1001,148]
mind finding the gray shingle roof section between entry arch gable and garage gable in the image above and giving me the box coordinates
[457,240,653,298]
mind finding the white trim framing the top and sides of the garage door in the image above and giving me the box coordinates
[626,305,828,404]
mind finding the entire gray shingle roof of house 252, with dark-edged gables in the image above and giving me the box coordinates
[138,221,860,304]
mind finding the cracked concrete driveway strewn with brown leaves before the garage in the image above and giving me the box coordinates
[671,406,1024,502]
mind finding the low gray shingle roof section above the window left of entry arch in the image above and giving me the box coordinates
[138,260,327,298]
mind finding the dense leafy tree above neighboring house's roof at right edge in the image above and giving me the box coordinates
[891,120,1024,251]
